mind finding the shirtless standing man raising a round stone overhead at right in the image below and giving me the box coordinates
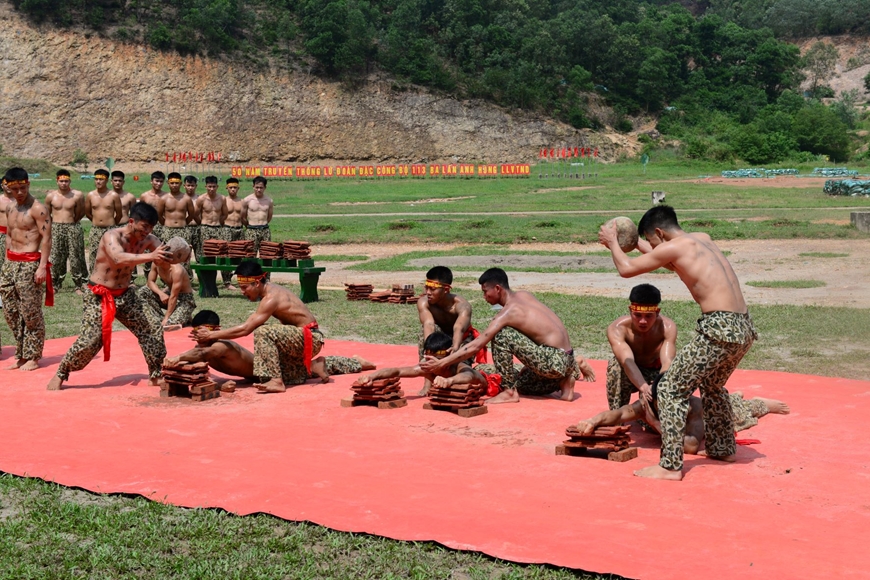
[598,205,758,481]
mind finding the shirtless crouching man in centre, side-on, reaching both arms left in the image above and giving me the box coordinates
[420,268,595,404]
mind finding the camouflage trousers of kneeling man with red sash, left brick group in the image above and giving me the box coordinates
[254,324,323,386]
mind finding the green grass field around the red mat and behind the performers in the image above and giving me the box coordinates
[6,156,870,579]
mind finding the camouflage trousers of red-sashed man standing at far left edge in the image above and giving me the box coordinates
[0,260,45,361]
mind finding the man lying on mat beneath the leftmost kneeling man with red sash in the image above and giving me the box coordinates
[166,310,376,386]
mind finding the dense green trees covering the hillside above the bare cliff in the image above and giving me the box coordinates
[11,0,870,163]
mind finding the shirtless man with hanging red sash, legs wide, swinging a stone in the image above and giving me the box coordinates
[48,202,172,391]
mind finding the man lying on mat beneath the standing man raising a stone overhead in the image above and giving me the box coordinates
[577,377,791,455]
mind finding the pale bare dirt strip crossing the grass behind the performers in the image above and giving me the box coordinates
[298,240,870,308]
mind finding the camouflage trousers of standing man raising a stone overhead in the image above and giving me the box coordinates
[658,311,758,471]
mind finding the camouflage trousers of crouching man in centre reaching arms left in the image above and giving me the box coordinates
[492,326,579,396]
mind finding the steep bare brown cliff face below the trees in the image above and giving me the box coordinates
[0,3,624,163]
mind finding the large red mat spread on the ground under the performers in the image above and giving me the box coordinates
[0,330,870,578]
